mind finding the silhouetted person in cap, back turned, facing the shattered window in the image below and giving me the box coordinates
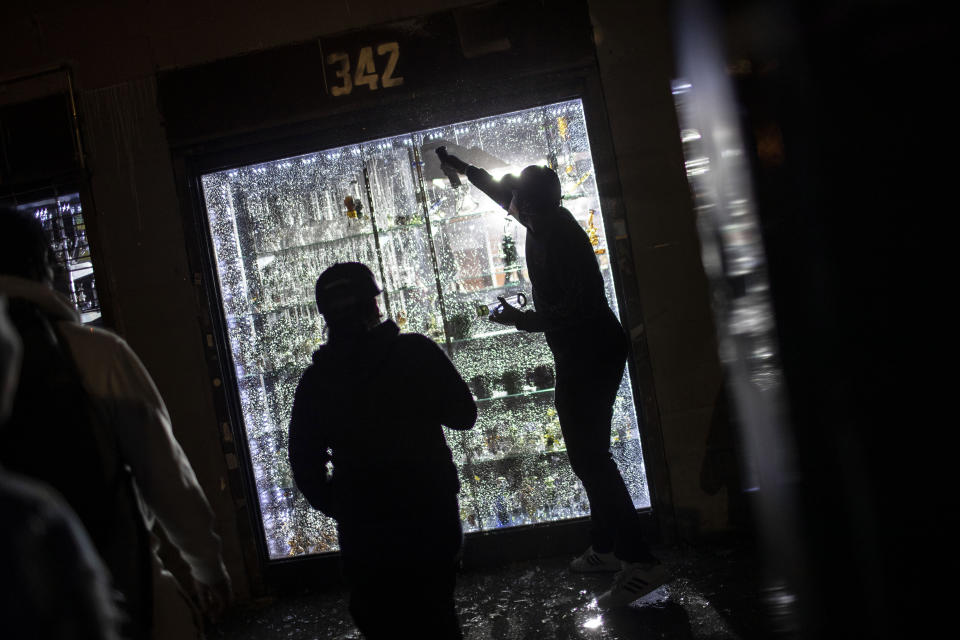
[289,262,477,638]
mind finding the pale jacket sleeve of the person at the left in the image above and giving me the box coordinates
[71,329,226,584]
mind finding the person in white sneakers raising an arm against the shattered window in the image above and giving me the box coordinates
[436,147,667,608]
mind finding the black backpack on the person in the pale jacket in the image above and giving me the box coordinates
[0,299,153,638]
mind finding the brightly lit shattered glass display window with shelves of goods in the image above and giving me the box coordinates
[201,100,650,559]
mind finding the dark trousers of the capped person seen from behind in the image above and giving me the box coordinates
[339,497,463,640]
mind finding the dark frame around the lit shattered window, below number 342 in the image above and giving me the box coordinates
[172,42,673,586]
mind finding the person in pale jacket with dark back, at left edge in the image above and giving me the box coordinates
[0,211,231,640]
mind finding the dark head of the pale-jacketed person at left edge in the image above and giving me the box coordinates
[0,209,56,284]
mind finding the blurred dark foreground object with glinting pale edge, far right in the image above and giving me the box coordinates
[673,0,952,638]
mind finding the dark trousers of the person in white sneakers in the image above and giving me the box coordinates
[551,323,654,562]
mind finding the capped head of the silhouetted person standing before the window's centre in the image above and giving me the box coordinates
[316,262,380,340]
